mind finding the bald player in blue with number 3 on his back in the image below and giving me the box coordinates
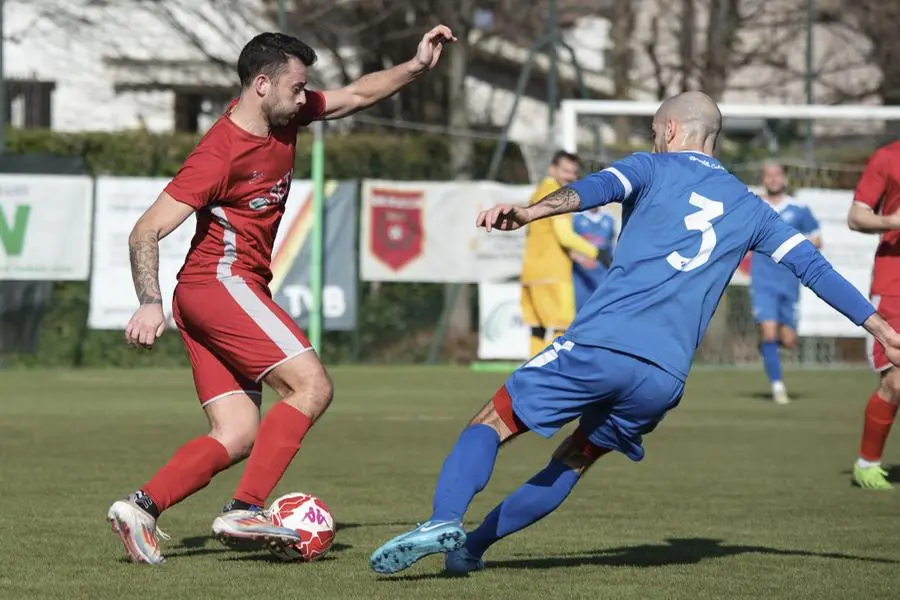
[369,92,900,573]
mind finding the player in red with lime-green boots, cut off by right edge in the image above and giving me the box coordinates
[847,141,900,490]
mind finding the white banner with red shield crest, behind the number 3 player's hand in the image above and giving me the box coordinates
[359,180,534,283]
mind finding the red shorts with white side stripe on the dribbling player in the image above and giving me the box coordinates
[172,277,311,405]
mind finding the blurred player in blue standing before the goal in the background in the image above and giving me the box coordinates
[750,163,822,404]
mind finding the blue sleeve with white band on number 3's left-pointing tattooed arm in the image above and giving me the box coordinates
[569,152,653,210]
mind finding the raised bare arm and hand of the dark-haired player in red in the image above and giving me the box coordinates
[321,25,456,119]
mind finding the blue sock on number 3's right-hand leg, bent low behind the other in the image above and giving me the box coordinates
[466,460,578,557]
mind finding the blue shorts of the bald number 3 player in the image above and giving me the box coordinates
[506,336,684,461]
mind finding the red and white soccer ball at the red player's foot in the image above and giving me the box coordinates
[269,492,334,562]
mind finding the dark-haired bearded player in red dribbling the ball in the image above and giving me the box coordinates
[107,25,456,564]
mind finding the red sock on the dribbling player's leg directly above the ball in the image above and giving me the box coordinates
[234,402,312,506]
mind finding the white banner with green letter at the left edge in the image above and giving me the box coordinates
[0,175,93,281]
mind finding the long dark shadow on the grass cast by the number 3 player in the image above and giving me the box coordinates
[380,538,900,581]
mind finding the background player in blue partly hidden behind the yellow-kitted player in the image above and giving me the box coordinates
[570,206,616,312]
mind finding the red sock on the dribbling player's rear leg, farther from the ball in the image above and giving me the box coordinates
[141,435,231,512]
